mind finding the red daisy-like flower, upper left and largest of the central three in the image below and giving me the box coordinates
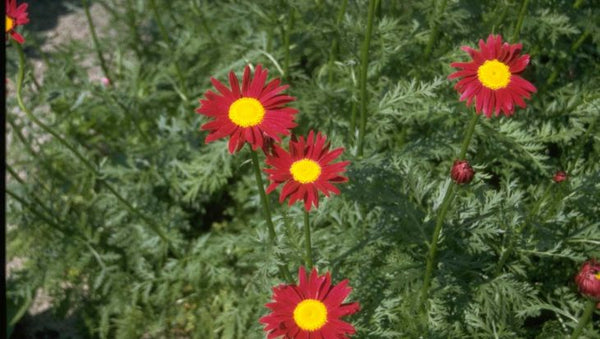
[196,65,298,153]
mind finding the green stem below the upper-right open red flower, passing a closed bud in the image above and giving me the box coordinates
[420,110,479,311]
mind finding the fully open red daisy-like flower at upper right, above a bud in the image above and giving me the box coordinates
[448,34,536,118]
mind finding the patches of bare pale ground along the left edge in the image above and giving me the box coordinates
[5,0,115,339]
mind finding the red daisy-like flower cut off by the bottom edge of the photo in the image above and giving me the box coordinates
[260,267,360,339]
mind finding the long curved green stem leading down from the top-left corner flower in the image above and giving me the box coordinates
[14,43,178,256]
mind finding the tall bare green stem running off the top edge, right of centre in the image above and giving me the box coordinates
[358,0,378,156]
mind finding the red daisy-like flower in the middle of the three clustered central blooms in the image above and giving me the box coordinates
[265,131,350,211]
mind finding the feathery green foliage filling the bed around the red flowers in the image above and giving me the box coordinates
[6,0,600,338]
